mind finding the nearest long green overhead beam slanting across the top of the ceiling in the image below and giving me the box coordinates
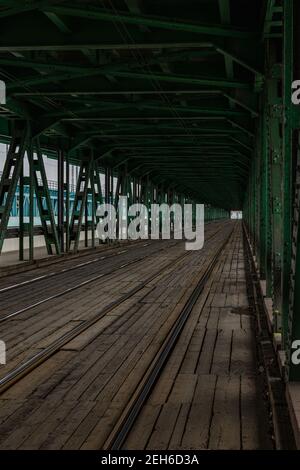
[45,5,257,39]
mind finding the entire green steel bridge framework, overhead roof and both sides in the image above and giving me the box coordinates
[0,0,300,381]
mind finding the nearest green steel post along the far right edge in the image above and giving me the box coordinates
[282,0,300,381]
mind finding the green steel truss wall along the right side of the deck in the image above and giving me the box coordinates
[244,0,300,380]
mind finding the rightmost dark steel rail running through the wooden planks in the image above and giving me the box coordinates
[103,229,234,450]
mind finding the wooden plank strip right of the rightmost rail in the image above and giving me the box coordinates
[124,225,273,450]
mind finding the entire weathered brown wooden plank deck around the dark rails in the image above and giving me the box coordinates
[0,224,271,449]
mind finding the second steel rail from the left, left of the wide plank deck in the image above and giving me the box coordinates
[0,224,225,323]
